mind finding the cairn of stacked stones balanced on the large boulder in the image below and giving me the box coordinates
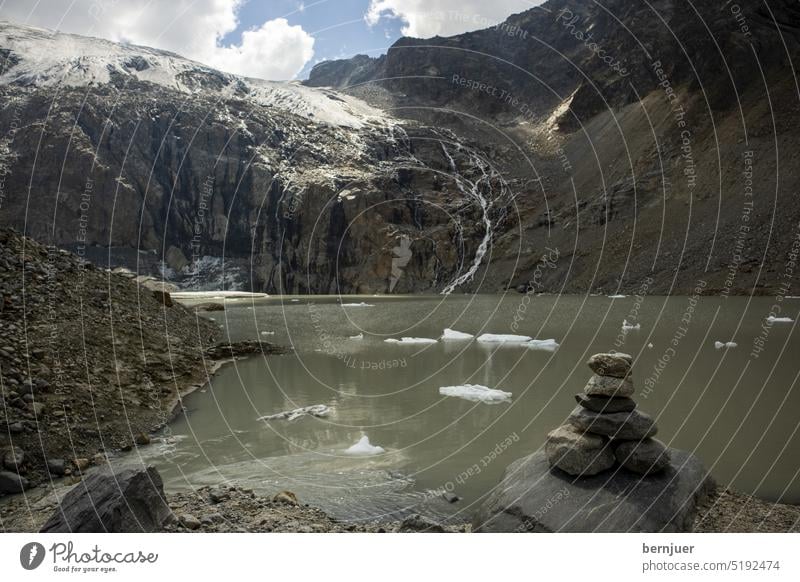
[545,353,670,476]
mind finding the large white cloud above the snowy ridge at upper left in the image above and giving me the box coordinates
[0,0,314,79]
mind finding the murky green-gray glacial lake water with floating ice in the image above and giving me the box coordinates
[128,293,800,521]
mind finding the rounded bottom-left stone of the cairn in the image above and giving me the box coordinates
[545,426,614,475]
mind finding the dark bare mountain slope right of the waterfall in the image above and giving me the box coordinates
[307,0,800,294]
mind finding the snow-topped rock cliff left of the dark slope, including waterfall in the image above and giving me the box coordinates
[0,23,510,293]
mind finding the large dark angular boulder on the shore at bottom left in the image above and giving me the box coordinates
[41,467,172,533]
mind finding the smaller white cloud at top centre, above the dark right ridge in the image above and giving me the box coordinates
[365,0,544,38]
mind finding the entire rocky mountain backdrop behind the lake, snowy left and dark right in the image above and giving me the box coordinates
[0,0,800,294]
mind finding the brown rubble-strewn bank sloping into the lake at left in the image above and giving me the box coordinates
[0,228,221,495]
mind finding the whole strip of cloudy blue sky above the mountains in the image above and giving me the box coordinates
[0,0,543,80]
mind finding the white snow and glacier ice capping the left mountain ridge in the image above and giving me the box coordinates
[0,21,388,128]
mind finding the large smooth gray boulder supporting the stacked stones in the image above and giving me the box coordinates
[473,449,714,532]
